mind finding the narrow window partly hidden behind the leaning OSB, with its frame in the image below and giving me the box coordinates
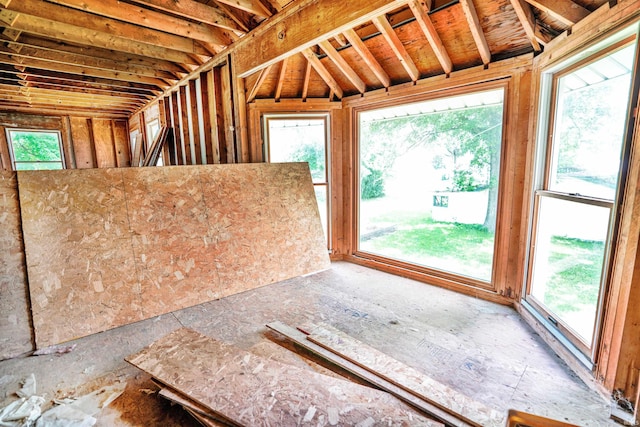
[265,114,331,247]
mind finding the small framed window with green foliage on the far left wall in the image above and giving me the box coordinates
[7,129,64,170]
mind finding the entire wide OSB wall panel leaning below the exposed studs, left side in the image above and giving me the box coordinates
[18,163,329,348]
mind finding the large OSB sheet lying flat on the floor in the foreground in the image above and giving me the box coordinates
[126,328,441,426]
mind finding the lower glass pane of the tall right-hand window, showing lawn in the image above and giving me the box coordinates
[530,197,610,345]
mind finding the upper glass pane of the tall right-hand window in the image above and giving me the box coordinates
[549,45,635,200]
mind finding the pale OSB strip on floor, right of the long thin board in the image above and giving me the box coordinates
[307,325,506,427]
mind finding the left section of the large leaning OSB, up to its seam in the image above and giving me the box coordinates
[18,169,142,348]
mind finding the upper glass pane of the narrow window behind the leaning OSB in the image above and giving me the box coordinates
[268,119,327,183]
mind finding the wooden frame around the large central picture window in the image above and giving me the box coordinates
[351,82,512,292]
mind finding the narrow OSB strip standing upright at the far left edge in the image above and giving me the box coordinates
[0,171,33,360]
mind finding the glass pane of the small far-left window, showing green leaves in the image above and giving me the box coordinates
[9,131,62,162]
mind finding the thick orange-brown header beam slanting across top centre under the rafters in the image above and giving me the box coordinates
[234,0,406,77]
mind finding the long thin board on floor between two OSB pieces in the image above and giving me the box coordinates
[266,321,456,427]
